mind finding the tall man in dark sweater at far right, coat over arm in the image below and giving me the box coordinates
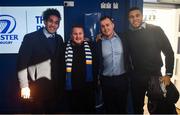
[126,7,174,114]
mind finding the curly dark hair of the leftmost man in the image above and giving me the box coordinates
[42,8,61,21]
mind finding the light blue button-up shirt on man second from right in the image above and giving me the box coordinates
[102,34,125,76]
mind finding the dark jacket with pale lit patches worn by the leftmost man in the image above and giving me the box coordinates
[17,29,64,100]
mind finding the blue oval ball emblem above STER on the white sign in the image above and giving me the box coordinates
[0,15,16,34]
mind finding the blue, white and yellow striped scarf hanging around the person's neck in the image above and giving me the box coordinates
[65,41,93,90]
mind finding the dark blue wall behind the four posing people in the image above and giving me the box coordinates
[0,0,143,113]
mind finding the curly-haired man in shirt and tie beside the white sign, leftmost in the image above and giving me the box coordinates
[17,9,64,113]
